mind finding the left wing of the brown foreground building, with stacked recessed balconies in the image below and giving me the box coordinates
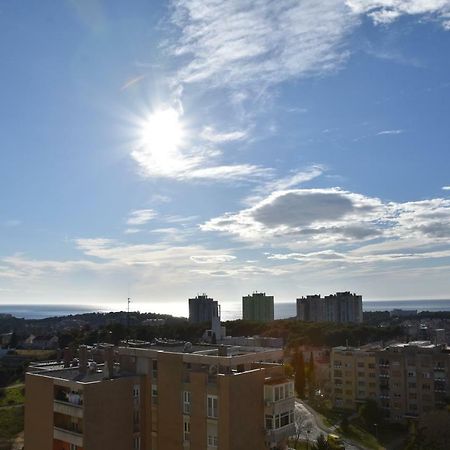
[25,350,144,450]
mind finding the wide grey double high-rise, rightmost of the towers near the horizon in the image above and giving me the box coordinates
[297,292,363,323]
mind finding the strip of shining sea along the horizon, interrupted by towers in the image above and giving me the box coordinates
[0,299,450,321]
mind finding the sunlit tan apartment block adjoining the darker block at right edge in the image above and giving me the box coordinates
[330,346,378,410]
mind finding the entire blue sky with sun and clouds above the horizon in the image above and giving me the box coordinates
[0,0,450,314]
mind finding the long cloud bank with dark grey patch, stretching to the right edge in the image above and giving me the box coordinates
[201,188,450,255]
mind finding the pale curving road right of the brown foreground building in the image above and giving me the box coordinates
[295,399,366,450]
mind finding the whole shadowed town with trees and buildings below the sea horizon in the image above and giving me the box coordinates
[0,292,450,450]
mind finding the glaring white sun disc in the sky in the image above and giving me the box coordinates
[139,107,186,174]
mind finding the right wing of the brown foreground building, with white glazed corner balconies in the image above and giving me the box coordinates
[120,342,295,450]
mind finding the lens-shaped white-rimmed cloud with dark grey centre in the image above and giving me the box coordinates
[202,188,385,241]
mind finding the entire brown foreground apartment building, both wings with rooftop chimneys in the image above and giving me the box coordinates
[25,341,295,450]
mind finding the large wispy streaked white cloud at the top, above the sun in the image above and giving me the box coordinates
[172,0,358,89]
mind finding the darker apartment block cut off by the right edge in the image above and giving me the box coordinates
[376,341,450,422]
